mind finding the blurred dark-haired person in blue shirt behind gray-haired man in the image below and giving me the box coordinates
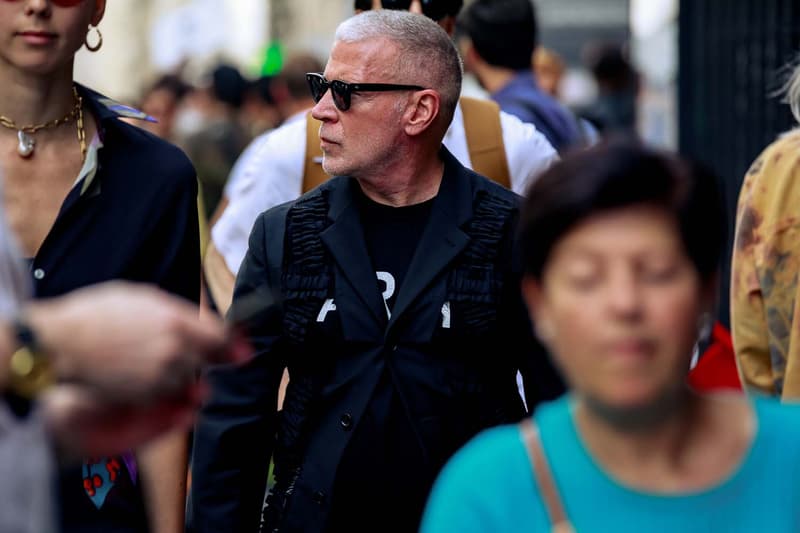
[458,0,582,152]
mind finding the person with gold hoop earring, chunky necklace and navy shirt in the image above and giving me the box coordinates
[0,0,200,532]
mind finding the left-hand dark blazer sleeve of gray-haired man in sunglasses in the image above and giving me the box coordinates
[187,215,285,533]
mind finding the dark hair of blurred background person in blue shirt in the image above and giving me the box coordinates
[458,0,538,70]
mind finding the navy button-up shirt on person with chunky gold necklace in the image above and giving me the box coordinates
[25,86,200,532]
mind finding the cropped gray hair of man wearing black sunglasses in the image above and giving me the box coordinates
[335,9,463,125]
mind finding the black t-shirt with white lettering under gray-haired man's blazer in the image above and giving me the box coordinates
[327,192,433,531]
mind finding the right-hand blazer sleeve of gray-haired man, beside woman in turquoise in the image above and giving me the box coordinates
[498,210,565,412]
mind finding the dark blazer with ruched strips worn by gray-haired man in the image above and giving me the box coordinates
[188,150,563,532]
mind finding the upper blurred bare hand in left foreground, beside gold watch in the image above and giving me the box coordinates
[27,282,249,404]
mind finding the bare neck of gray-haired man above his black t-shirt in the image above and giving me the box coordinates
[357,150,444,207]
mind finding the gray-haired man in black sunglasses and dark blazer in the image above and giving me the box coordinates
[189,10,562,532]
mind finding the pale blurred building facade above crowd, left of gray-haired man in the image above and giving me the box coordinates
[75,0,352,102]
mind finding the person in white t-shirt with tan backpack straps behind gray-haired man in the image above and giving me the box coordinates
[204,0,558,312]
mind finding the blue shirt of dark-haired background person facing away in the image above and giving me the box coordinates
[492,71,582,152]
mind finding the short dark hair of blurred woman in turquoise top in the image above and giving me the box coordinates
[518,139,726,281]
